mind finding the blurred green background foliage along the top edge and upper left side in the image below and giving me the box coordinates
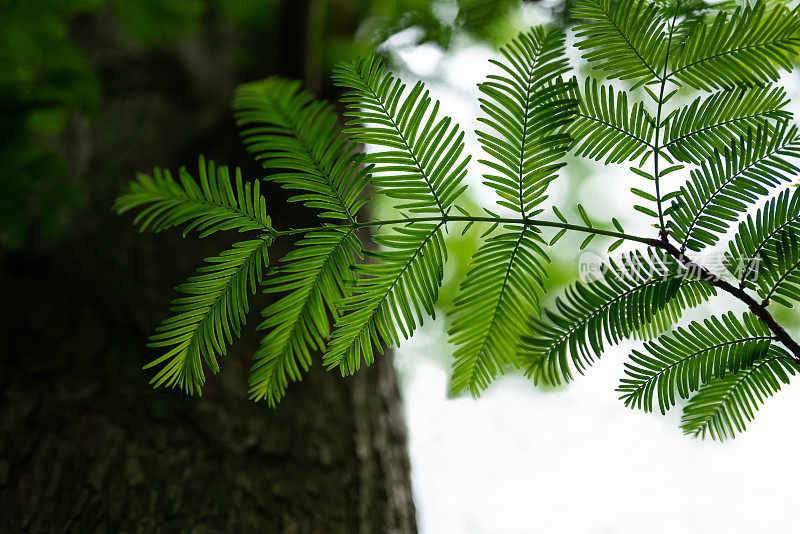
[0,0,561,248]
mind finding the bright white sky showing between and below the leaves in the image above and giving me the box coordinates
[380,9,800,534]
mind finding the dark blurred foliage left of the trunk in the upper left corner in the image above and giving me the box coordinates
[0,0,100,248]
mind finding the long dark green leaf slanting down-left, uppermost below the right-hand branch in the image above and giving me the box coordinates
[521,251,714,384]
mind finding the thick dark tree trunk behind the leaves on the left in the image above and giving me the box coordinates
[0,5,416,533]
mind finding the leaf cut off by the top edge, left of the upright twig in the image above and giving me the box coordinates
[572,0,667,86]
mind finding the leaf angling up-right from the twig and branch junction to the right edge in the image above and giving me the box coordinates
[668,124,800,251]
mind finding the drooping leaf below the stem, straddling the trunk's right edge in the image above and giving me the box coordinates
[324,223,447,374]
